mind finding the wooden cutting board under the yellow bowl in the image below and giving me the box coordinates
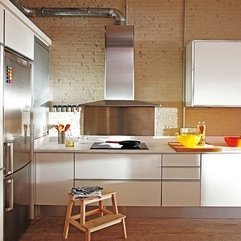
[168,142,222,152]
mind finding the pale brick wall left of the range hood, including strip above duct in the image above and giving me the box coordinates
[22,0,125,104]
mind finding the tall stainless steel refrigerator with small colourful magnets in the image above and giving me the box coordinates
[1,48,32,241]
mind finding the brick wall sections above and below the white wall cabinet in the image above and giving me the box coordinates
[184,0,241,135]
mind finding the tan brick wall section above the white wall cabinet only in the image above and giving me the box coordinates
[185,0,241,43]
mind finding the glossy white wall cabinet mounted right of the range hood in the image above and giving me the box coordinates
[184,40,241,107]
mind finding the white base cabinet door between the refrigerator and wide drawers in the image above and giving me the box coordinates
[35,153,74,205]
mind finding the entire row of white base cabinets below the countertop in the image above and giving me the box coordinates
[32,152,241,207]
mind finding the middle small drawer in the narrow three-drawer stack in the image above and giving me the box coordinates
[162,167,200,180]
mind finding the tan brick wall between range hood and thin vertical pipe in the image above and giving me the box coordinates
[128,0,183,104]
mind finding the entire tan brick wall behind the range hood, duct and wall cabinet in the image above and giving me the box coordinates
[0,0,240,240]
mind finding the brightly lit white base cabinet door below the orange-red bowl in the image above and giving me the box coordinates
[201,154,241,206]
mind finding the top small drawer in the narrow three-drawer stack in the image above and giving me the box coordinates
[162,154,200,166]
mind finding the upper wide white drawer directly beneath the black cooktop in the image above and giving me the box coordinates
[75,154,161,179]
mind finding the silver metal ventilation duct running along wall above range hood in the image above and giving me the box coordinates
[10,0,126,25]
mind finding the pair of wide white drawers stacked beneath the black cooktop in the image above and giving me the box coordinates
[75,154,161,206]
